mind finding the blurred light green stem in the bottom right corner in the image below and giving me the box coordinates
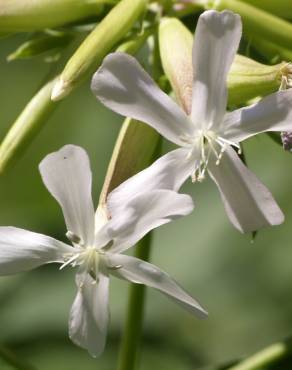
[228,340,291,370]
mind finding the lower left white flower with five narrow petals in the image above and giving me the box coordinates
[0,145,206,356]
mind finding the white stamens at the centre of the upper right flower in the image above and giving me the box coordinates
[183,130,241,182]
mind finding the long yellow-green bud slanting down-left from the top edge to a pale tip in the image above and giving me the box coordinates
[52,0,147,100]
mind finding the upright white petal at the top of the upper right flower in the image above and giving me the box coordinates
[192,10,241,129]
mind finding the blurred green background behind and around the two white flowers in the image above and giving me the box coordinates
[0,37,292,370]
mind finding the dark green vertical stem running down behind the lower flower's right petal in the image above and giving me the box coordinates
[118,233,152,370]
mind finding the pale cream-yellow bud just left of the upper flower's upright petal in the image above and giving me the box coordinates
[159,18,193,114]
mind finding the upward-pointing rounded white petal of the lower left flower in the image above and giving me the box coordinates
[39,145,94,245]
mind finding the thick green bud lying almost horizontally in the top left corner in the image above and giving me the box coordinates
[0,0,103,32]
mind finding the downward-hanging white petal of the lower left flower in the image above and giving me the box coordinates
[69,273,109,357]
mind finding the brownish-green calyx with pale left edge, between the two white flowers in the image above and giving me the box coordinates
[99,118,159,206]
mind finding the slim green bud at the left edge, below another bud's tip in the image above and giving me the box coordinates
[0,79,57,173]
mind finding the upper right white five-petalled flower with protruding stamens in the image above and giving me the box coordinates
[92,10,292,232]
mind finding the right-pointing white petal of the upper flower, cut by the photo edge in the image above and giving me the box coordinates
[222,90,292,142]
